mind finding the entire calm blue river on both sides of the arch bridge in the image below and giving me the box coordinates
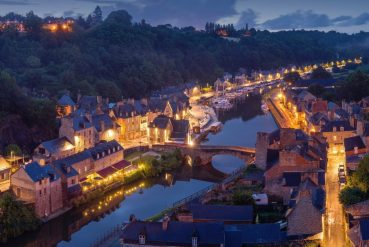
[7,93,277,247]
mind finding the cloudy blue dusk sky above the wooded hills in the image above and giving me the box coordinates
[0,0,369,33]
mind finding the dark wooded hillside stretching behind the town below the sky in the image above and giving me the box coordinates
[0,8,369,153]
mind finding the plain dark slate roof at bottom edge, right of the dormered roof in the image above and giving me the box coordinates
[224,224,286,247]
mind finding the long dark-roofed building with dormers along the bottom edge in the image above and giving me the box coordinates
[120,218,286,247]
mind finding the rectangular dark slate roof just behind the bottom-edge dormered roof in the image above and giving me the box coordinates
[188,204,253,222]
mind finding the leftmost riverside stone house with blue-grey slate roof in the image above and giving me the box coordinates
[10,162,63,218]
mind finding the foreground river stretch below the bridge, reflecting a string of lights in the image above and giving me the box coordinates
[4,165,226,247]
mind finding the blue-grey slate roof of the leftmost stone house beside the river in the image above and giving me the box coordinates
[22,162,59,182]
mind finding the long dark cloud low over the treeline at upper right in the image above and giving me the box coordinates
[260,10,332,30]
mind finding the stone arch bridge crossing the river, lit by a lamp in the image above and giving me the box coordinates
[152,143,255,165]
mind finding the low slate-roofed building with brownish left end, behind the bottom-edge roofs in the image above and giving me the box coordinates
[176,204,254,224]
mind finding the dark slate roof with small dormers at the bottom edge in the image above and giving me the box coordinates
[120,221,224,246]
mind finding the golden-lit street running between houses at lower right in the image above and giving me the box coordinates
[324,150,345,247]
